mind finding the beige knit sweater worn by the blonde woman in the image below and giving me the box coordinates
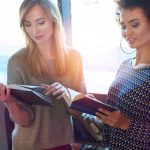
[7,49,85,150]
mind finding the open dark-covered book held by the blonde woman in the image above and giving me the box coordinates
[8,84,54,106]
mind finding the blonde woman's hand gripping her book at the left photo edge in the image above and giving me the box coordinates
[0,83,14,103]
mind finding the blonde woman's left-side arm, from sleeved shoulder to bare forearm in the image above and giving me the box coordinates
[3,55,34,126]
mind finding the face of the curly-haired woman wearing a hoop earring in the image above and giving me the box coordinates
[120,8,150,49]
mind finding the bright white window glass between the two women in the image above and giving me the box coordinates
[71,0,135,92]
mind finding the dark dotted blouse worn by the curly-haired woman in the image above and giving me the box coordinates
[102,59,150,150]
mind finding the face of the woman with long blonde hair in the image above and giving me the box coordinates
[24,5,53,45]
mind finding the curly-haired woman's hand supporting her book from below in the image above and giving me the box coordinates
[96,109,130,130]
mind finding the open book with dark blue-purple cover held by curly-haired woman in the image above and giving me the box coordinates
[63,89,117,115]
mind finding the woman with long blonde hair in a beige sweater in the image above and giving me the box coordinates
[0,0,86,150]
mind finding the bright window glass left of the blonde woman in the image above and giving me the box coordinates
[0,0,57,83]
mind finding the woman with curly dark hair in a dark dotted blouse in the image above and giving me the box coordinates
[96,0,150,150]
